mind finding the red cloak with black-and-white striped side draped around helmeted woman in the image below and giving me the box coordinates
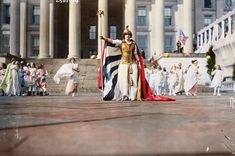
[98,43,175,101]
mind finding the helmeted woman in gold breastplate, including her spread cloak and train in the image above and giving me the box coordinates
[98,26,175,101]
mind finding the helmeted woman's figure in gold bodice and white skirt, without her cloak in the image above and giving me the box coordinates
[101,26,139,101]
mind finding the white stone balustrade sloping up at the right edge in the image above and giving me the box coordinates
[197,9,235,53]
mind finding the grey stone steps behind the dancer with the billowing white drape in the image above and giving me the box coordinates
[23,59,213,95]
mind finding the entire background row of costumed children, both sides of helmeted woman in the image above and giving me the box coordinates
[0,58,223,96]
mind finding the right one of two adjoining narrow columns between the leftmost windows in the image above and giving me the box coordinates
[20,1,27,58]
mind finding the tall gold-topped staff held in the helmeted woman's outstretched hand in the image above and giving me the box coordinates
[96,10,104,100]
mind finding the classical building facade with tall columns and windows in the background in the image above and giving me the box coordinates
[0,0,235,58]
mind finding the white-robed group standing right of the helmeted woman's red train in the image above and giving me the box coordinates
[145,60,223,96]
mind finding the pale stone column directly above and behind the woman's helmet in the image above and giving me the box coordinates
[123,0,136,40]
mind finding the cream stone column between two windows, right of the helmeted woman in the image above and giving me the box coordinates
[151,0,165,57]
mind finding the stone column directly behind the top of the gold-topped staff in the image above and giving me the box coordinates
[97,0,108,58]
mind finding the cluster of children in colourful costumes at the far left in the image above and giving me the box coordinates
[0,58,48,96]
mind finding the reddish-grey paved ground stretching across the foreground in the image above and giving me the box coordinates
[0,93,235,156]
